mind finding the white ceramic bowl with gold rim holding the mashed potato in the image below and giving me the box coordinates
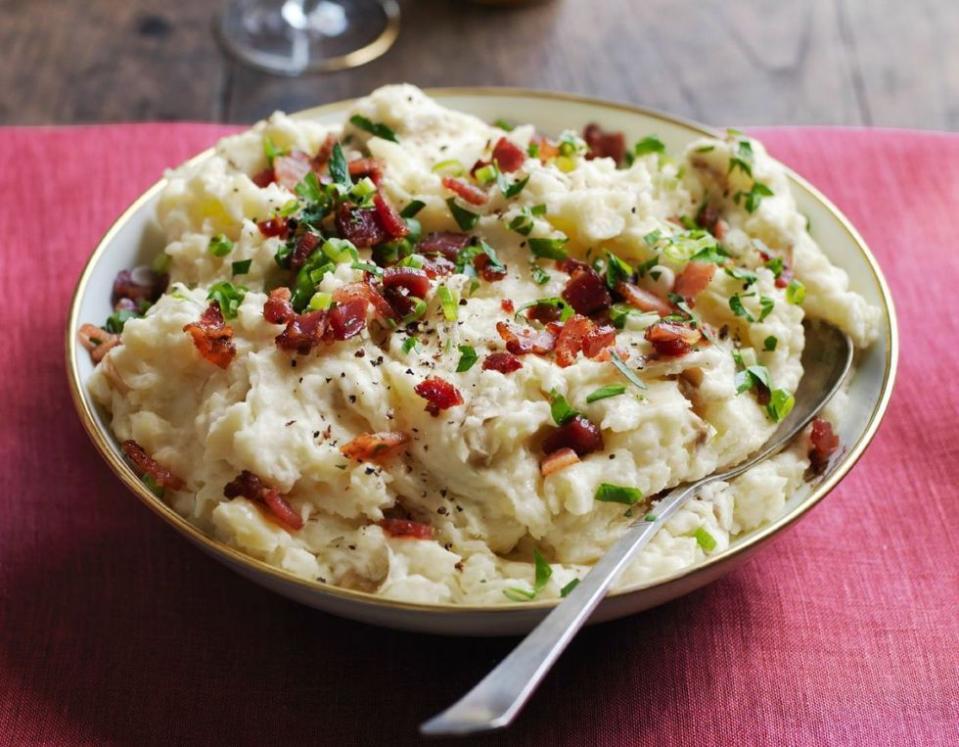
[66,88,898,635]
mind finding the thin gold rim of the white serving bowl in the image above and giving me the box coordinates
[66,87,899,614]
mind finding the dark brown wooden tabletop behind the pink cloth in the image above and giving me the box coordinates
[0,0,959,130]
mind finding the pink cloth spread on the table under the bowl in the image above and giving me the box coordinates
[0,124,959,747]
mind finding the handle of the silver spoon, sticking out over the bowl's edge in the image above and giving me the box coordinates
[420,481,692,735]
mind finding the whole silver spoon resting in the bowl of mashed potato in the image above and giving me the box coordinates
[420,322,853,735]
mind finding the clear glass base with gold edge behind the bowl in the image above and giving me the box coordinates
[215,0,400,76]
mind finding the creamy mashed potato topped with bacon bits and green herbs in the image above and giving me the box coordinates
[90,86,878,604]
